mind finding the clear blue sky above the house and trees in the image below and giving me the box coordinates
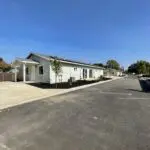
[0,0,150,67]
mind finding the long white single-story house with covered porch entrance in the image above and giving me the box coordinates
[12,53,104,84]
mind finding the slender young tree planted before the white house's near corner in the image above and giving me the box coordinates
[51,59,62,88]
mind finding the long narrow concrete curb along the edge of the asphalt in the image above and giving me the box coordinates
[0,77,122,112]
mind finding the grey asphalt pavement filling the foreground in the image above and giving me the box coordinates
[0,78,150,150]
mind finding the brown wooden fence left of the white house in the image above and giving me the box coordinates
[0,72,15,82]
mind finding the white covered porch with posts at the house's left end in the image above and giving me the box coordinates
[12,58,39,82]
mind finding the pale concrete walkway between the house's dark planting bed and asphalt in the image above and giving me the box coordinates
[0,77,119,110]
